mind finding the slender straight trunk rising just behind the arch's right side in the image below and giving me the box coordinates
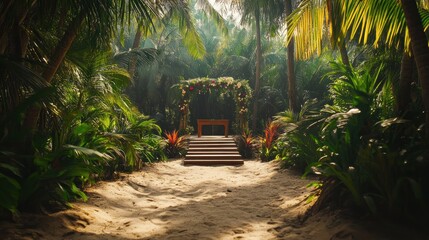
[252,8,262,131]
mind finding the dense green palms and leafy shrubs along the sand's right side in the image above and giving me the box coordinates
[276,64,429,221]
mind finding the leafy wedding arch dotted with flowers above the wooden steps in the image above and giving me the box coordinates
[178,77,252,132]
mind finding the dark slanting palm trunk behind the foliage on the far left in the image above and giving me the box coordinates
[23,11,85,133]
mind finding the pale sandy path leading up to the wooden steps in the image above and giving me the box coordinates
[0,159,422,240]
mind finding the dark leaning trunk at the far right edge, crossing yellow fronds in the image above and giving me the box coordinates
[401,0,429,139]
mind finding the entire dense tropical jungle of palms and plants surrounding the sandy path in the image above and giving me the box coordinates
[0,0,429,230]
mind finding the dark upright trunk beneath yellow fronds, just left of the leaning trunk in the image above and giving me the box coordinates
[395,52,413,114]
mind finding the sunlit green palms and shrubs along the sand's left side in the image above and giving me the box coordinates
[0,51,165,214]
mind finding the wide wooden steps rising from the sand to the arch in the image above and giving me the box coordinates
[183,136,244,166]
